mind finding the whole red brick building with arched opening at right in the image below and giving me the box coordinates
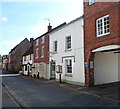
[84,0,120,86]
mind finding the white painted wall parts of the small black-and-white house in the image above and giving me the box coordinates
[23,54,33,75]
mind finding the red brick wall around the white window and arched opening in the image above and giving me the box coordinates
[84,2,120,86]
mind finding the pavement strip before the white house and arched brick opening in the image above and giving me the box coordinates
[48,80,120,103]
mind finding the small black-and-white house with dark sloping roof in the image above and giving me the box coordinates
[22,45,33,76]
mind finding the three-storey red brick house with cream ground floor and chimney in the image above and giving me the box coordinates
[32,23,66,79]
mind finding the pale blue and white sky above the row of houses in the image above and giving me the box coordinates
[0,0,83,55]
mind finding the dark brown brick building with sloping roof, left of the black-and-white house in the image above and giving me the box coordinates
[8,38,32,72]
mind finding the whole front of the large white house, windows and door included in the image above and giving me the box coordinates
[49,16,85,86]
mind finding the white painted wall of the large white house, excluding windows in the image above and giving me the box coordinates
[50,19,85,83]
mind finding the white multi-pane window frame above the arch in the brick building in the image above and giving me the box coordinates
[96,15,110,37]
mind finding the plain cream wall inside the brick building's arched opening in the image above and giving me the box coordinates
[94,52,118,85]
